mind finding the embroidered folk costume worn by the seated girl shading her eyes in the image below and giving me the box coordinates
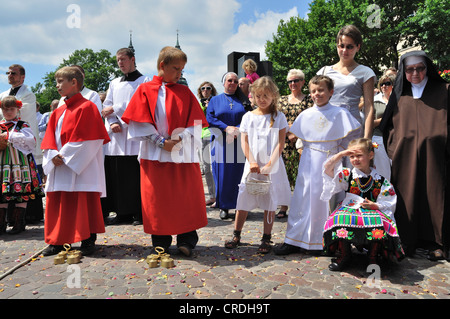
[323,168,404,260]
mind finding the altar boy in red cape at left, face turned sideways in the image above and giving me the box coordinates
[41,67,109,256]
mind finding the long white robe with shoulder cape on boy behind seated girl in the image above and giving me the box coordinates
[285,104,361,250]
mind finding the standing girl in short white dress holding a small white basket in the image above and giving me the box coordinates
[225,76,291,254]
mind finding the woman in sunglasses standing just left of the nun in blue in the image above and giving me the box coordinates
[197,81,217,206]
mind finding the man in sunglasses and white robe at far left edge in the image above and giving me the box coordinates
[0,64,44,226]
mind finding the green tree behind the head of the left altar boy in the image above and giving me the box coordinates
[31,49,121,113]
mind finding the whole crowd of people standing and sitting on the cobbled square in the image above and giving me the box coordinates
[0,25,450,271]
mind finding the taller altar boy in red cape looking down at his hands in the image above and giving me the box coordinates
[122,47,208,256]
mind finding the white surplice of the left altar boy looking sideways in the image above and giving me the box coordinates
[42,111,106,197]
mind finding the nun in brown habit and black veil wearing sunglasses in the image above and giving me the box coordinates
[380,51,450,260]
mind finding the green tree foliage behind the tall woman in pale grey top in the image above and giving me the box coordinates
[266,0,426,94]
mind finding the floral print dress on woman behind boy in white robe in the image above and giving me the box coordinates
[278,95,314,188]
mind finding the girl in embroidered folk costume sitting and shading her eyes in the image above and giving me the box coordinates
[321,138,404,271]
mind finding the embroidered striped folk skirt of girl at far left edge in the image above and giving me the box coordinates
[0,145,45,203]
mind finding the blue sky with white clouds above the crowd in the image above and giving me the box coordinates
[0,0,311,100]
